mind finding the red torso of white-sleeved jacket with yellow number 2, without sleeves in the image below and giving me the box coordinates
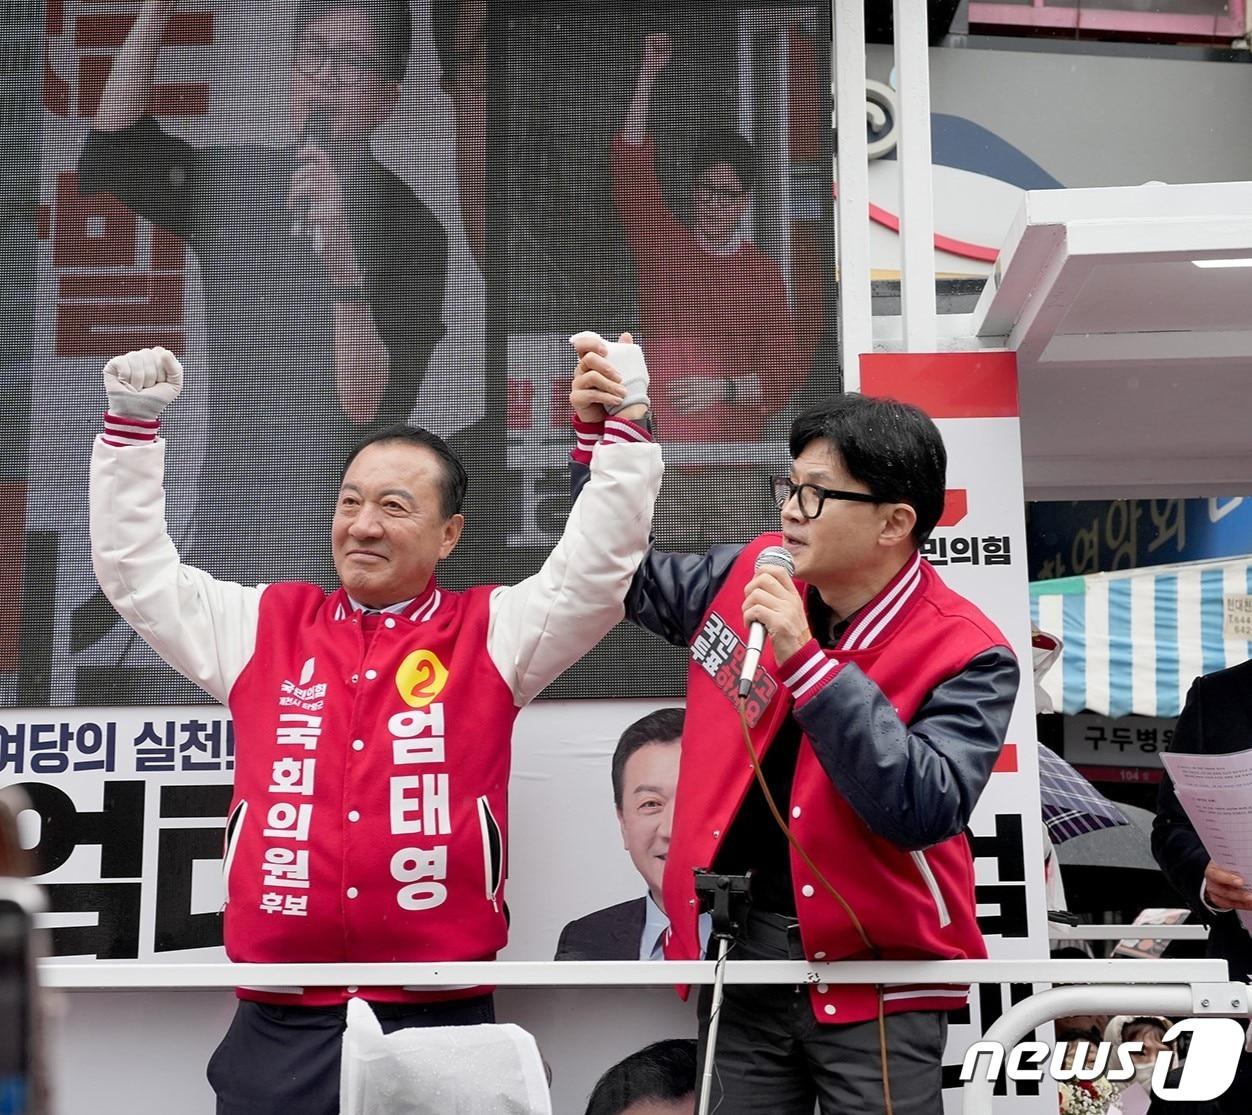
[224,582,517,1005]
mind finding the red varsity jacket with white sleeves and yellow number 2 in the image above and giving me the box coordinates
[90,419,661,1005]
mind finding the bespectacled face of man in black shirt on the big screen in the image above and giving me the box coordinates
[292,4,399,151]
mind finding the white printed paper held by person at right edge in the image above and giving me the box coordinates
[1161,750,1252,932]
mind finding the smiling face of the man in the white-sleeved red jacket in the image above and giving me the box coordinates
[331,442,464,608]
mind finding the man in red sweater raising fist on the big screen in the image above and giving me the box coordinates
[612,33,808,442]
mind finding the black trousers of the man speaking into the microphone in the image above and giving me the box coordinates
[696,911,948,1115]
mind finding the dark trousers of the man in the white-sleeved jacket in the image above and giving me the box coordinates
[208,995,496,1115]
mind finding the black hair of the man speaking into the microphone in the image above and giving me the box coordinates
[790,394,948,546]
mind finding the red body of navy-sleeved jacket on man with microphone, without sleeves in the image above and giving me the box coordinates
[665,534,1007,1022]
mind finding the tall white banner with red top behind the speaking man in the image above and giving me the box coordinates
[861,350,1057,1115]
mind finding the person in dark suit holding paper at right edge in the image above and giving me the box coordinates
[1152,662,1252,1115]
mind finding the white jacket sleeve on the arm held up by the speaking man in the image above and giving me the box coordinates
[487,427,662,707]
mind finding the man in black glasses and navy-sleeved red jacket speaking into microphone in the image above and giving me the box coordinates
[575,385,1018,1115]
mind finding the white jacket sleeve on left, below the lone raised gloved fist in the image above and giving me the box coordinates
[90,437,262,703]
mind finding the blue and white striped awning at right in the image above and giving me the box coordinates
[1030,556,1252,717]
